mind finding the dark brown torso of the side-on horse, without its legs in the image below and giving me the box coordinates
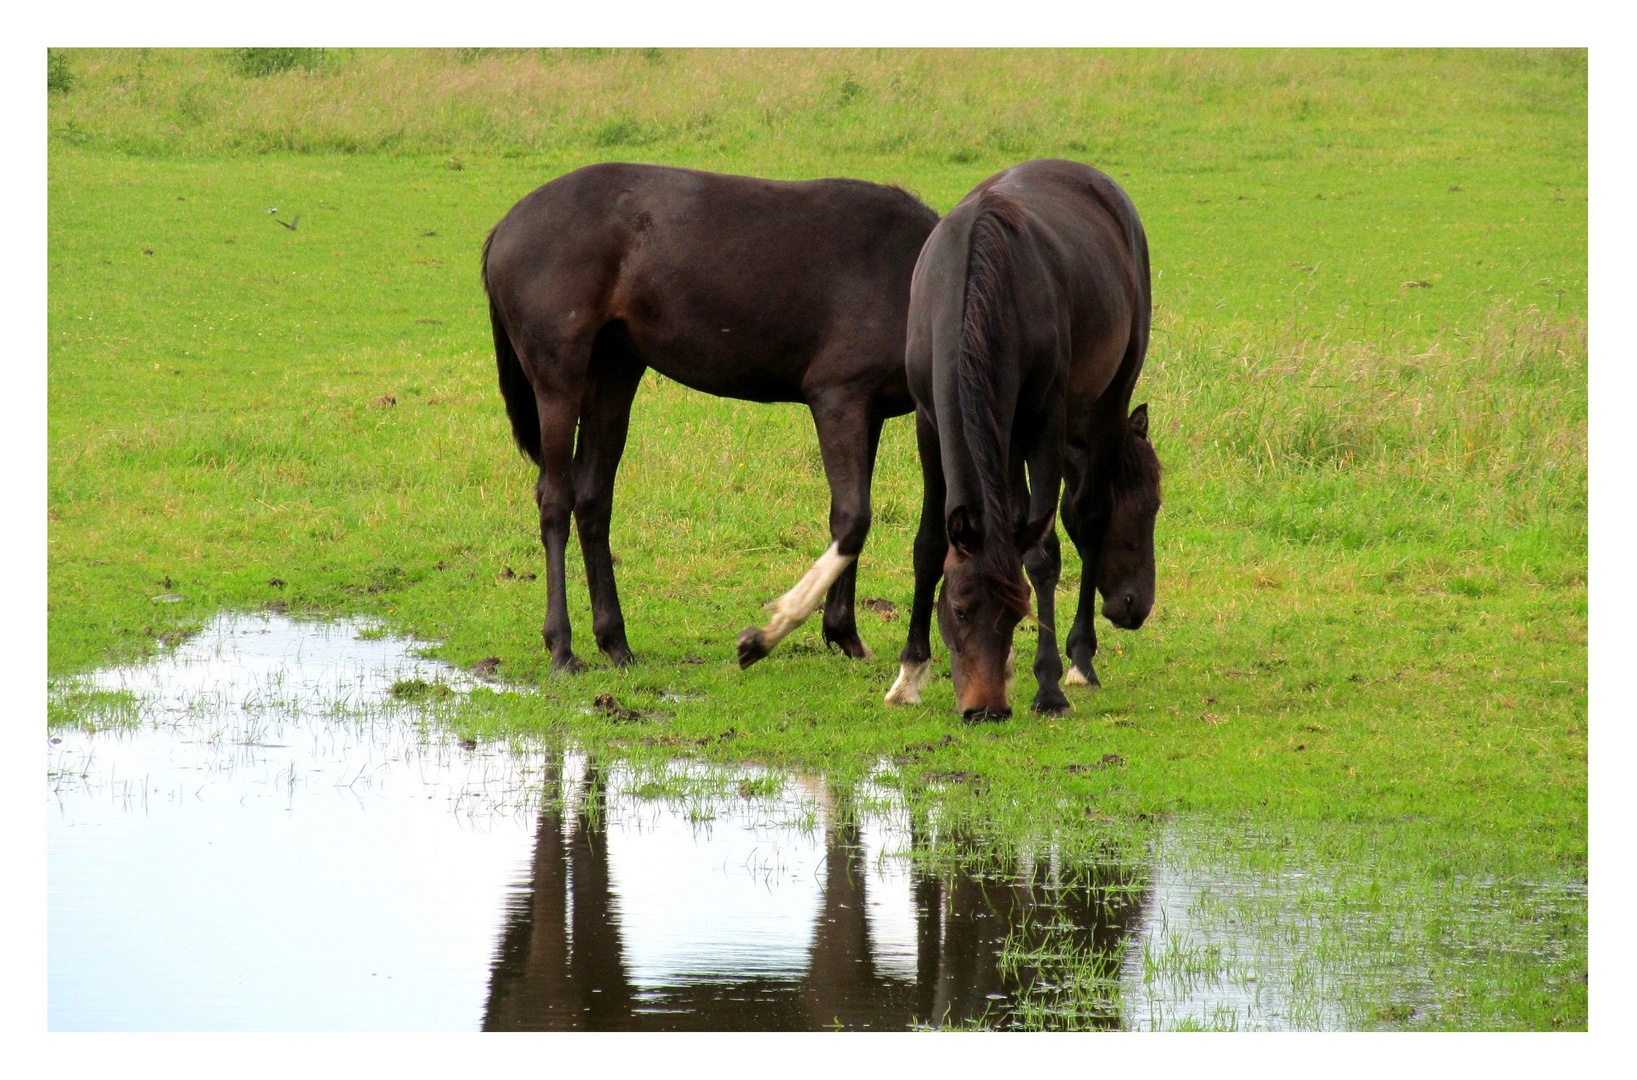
[486,164,938,407]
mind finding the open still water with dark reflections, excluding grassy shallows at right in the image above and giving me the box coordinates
[47,615,1138,1031]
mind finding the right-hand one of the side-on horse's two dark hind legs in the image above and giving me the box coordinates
[575,342,643,668]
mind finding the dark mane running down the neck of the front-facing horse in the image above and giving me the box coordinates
[956,191,1028,614]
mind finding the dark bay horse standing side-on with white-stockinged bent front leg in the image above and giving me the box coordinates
[483,164,938,673]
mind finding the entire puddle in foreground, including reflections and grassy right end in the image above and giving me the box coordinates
[46,615,1586,1031]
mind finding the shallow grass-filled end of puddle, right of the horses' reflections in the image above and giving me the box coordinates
[1121,820,1586,1031]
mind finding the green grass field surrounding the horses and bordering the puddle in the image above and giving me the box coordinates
[49,49,1588,1028]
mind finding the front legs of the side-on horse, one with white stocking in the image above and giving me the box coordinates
[738,399,879,668]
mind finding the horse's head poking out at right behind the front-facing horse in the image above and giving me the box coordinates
[1097,403,1159,630]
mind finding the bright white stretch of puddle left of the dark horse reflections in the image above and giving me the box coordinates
[47,617,539,1031]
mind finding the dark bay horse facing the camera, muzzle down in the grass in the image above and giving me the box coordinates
[887,160,1159,720]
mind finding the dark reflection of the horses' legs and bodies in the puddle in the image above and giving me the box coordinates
[483,764,1139,1031]
